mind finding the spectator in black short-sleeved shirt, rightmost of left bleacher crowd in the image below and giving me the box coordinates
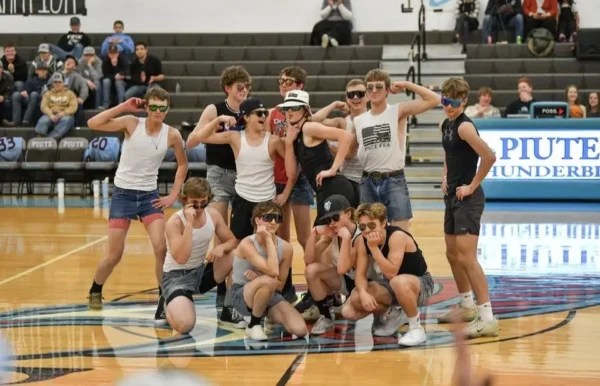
[125,42,165,99]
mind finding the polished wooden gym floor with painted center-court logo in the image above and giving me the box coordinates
[0,198,600,386]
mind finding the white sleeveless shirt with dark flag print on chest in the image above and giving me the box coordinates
[354,104,406,172]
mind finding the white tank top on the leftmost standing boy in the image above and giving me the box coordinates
[115,118,169,192]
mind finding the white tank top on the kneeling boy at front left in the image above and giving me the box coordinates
[163,210,215,272]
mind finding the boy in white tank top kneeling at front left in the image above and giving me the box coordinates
[161,177,246,334]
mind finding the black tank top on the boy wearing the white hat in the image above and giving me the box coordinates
[294,122,333,192]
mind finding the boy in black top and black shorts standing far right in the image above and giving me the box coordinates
[438,78,498,338]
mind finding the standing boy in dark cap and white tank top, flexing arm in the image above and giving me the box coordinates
[186,98,285,241]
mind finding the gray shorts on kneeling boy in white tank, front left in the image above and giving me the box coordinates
[160,263,218,304]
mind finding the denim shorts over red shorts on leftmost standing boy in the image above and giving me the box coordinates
[109,186,164,228]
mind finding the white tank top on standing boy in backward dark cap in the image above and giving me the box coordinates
[235,131,277,202]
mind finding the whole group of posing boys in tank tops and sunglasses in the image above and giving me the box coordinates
[82,66,498,346]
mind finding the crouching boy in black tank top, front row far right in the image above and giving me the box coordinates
[342,202,434,346]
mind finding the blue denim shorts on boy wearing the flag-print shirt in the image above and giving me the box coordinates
[360,173,412,222]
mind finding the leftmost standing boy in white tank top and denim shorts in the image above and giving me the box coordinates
[88,87,188,319]
